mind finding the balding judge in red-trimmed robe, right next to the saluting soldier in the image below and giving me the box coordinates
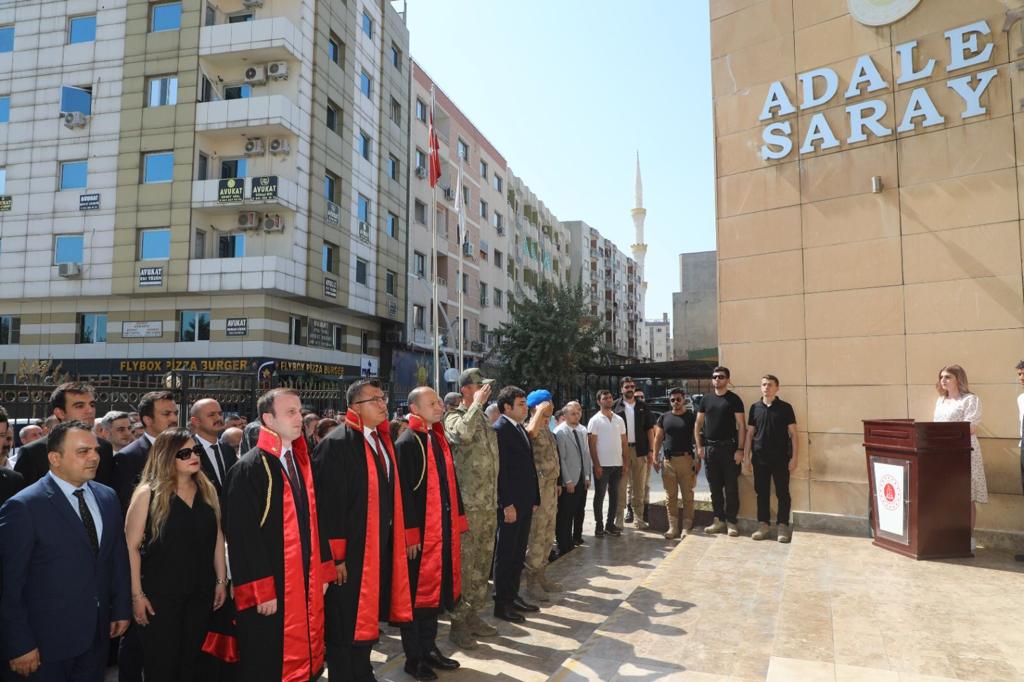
[395,403,469,677]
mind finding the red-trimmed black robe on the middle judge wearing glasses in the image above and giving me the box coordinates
[312,410,416,647]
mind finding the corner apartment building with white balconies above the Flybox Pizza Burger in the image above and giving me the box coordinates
[0,0,410,391]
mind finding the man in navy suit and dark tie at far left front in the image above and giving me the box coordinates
[0,421,131,681]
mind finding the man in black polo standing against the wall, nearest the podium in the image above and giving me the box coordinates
[744,374,797,543]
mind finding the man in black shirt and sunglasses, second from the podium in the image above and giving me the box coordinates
[693,367,746,538]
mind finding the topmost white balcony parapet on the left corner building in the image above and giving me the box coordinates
[199,16,303,63]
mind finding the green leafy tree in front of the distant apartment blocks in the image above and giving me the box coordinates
[488,282,608,391]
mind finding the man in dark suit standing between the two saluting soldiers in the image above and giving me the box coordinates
[494,386,541,623]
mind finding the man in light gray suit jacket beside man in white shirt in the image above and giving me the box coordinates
[555,400,594,556]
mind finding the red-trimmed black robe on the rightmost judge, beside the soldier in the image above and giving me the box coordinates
[395,415,469,615]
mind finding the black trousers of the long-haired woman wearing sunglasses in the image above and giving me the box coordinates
[139,590,213,682]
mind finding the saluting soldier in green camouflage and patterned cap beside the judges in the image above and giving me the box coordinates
[444,368,498,649]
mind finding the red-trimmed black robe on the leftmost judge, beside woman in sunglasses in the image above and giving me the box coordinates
[222,427,337,682]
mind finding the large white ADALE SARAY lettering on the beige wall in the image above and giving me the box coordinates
[758,20,998,161]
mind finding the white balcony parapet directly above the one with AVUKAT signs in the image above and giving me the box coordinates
[196,94,299,137]
